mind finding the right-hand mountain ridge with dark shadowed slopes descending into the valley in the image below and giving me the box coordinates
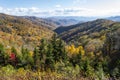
[55,19,120,42]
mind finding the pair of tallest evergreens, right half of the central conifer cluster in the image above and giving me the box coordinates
[51,34,67,62]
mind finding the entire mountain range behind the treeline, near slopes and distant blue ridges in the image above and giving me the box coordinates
[0,13,120,49]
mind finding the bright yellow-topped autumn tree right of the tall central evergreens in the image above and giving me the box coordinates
[66,44,85,67]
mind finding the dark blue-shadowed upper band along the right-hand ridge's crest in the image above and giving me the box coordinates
[55,19,114,34]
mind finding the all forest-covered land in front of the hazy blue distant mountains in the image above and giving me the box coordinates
[0,14,120,80]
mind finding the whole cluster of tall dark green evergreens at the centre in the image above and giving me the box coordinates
[38,34,67,70]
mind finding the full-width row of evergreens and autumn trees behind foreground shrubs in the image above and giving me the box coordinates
[0,31,120,80]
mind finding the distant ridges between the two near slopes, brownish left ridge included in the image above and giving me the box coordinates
[20,16,96,30]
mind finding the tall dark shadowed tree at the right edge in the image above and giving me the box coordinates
[103,29,120,77]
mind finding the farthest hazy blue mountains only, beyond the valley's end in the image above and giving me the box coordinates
[45,16,96,27]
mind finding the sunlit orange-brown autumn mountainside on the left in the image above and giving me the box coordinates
[0,14,54,48]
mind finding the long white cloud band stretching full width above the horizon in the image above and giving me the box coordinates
[0,7,120,17]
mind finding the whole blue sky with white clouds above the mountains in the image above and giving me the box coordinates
[0,0,120,17]
